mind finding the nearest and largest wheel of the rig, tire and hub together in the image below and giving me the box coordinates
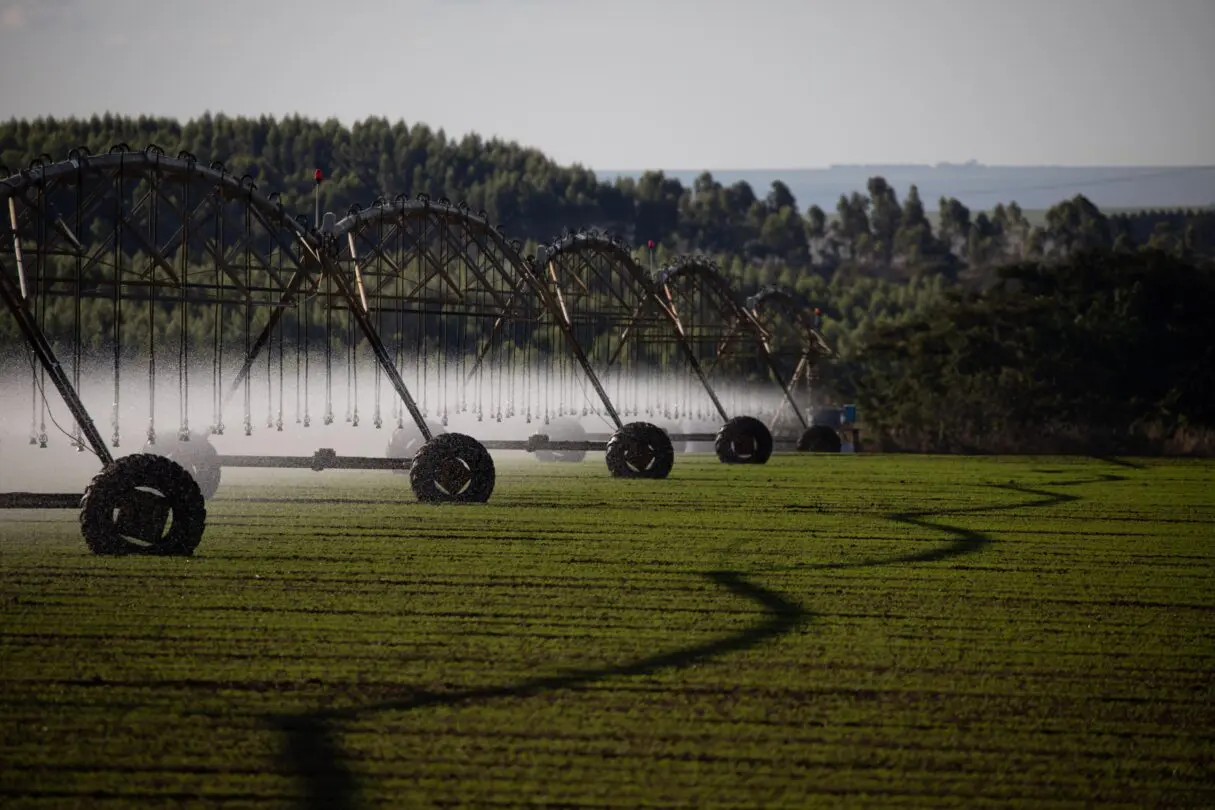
[80,453,207,556]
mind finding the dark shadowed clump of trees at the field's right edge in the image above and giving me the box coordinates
[840,249,1215,454]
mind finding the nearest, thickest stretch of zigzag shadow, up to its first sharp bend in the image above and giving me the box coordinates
[273,571,810,810]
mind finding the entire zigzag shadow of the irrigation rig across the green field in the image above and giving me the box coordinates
[271,475,1126,810]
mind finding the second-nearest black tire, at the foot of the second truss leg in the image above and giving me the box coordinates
[409,434,496,504]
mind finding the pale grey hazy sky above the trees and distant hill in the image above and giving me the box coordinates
[0,0,1215,170]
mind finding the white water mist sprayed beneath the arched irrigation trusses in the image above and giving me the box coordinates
[0,352,797,492]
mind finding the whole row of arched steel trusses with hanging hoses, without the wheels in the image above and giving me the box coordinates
[0,145,821,551]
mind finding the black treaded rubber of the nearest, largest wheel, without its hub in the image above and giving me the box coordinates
[80,453,207,556]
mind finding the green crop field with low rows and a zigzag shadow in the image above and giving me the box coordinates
[0,455,1215,809]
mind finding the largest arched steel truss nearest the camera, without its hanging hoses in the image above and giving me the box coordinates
[0,146,432,449]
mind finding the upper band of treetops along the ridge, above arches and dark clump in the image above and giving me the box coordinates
[0,114,1215,276]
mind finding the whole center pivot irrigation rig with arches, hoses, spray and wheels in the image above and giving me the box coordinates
[0,145,845,555]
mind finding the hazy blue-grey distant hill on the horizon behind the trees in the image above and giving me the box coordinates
[597,163,1215,211]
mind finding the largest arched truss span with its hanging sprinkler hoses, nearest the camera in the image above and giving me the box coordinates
[0,145,461,539]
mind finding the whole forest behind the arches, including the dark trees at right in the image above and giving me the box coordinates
[7,115,1215,452]
